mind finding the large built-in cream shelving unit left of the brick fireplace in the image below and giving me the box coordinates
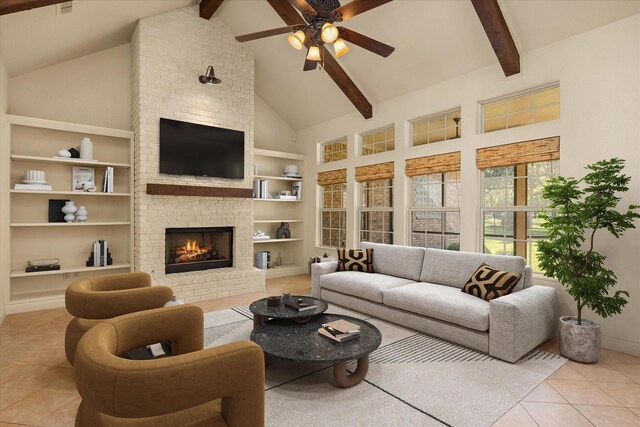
[0,115,133,313]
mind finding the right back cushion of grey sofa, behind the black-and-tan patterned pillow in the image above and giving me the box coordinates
[420,248,526,290]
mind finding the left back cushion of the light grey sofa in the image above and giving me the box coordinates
[360,242,424,285]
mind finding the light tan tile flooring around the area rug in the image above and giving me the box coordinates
[0,275,640,427]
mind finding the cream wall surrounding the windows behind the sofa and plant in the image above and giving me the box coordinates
[297,15,640,355]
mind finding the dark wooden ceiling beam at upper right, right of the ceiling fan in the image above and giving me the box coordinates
[471,0,520,77]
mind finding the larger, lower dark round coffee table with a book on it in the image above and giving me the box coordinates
[251,314,382,387]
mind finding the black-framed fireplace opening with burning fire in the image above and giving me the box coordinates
[165,227,233,274]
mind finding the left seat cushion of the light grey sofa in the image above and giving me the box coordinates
[320,271,415,303]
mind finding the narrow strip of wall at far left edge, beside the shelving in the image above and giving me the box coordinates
[0,55,9,322]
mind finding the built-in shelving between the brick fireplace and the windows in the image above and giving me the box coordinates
[253,149,307,277]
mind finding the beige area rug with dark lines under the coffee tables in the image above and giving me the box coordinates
[205,305,566,427]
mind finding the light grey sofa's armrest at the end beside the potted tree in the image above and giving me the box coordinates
[489,285,557,362]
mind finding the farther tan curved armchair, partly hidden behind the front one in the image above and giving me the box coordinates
[64,273,173,365]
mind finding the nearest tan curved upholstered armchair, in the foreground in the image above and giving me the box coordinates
[75,304,264,427]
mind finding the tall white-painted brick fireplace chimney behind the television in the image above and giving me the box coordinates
[131,4,265,302]
